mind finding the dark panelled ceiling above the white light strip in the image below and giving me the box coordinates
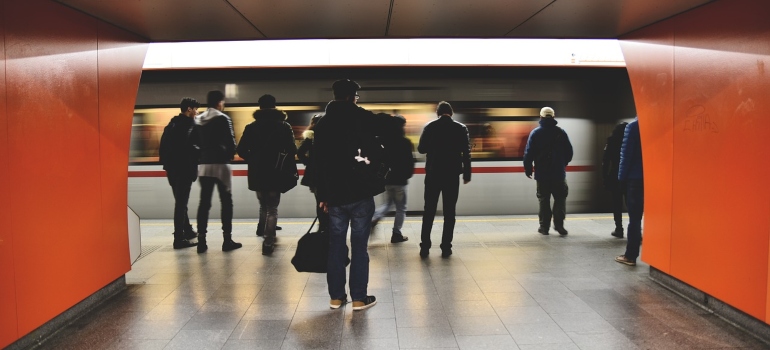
[54,0,714,42]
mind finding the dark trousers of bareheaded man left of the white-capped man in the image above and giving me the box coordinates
[420,176,460,249]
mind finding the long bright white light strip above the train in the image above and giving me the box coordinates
[143,39,626,69]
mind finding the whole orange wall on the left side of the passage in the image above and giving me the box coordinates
[0,0,147,347]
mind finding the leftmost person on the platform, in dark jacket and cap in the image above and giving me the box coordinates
[158,97,200,249]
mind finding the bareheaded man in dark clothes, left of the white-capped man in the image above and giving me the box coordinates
[417,101,471,258]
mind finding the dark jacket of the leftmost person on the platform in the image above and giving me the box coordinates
[158,114,200,181]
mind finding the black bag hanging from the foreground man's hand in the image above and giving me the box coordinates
[291,217,350,273]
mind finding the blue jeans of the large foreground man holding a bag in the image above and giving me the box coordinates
[326,197,374,300]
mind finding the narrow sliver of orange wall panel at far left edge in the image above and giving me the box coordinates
[0,2,18,348]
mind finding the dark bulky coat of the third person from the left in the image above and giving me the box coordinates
[237,109,297,192]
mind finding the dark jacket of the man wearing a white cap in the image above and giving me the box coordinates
[524,118,573,181]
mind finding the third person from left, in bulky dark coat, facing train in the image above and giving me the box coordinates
[236,95,297,255]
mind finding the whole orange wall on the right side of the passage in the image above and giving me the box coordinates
[621,0,770,322]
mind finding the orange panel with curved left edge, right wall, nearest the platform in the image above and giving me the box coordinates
[621,24,674,273]
